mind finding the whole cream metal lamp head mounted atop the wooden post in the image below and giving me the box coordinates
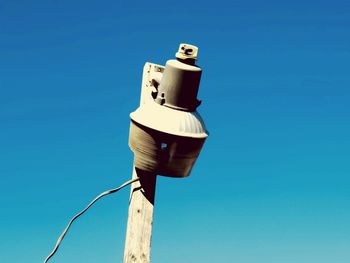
[129,44,208,177]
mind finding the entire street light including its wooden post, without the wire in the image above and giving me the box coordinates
[124,44,208,263]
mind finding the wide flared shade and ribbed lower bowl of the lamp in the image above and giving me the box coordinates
[129,102,208,177]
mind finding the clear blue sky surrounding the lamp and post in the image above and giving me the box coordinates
[0,0,350,263]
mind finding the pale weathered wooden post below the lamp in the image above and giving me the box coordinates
[124,167,157,263]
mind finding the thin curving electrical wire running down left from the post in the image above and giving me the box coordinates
[44,178,140,263]
